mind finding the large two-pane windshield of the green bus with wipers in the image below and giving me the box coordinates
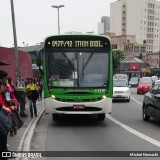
[46,50,109,88]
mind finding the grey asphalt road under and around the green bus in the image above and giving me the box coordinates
[31,88,160,160]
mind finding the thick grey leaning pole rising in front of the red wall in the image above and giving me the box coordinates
[10,0,20,78]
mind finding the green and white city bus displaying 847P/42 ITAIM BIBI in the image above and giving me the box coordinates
[37,34,113,121]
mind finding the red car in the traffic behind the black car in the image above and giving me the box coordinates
[137,77,152,94]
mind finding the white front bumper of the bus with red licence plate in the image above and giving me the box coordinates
[45,98,112,114]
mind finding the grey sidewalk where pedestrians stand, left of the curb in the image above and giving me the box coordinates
[7,101,44,151]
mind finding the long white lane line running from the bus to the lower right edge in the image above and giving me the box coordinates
[106,114,160,148]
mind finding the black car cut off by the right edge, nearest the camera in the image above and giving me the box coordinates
[142,85,160,121]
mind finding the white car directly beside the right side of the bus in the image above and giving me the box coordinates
[112,79,130,102]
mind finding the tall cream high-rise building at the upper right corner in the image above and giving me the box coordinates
[110,0,160,53]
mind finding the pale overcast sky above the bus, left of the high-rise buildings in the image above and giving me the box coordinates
[0,0,117,47]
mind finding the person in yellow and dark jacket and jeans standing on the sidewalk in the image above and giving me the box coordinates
[26,78,39,118]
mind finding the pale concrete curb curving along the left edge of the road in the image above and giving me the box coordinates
[16,107,45,160]
